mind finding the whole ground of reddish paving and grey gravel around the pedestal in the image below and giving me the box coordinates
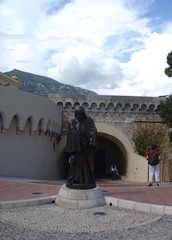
[0,179,172,240]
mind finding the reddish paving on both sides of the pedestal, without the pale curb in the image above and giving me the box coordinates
[0,178,172,206]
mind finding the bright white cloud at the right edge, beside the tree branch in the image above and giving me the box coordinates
[118,33,172,96]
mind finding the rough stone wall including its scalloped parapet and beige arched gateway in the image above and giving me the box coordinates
[49,94,162,182]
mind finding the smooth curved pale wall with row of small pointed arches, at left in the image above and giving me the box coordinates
[0,86,62,179]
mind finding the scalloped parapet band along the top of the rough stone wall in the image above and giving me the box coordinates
[49,94,162,113]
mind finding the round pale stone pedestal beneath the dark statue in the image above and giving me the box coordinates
[55,184,105,209]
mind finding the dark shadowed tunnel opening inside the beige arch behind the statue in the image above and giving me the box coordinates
[94,136,126,178]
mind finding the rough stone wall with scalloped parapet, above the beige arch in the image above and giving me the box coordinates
[49,94,163,144]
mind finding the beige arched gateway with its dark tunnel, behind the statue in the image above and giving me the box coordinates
[59,123,148,182]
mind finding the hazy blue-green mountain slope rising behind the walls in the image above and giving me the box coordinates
[4,69,97,96]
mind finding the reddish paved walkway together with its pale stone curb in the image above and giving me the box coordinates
[0,178,172,214]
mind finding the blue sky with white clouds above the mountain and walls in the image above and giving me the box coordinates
[0,0,172,96]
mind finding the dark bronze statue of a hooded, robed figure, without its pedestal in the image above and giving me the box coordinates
[66,106,97,189]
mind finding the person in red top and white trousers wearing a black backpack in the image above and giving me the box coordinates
[146,145,161,187]
